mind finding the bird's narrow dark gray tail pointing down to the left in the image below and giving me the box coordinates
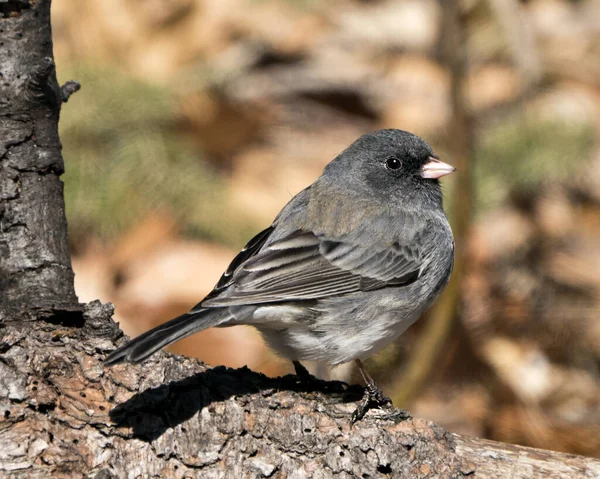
[104,308,231,366]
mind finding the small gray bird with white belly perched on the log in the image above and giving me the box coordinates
[105,129,455,421]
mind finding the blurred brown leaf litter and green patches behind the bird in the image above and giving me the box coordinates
[53,0,600,457]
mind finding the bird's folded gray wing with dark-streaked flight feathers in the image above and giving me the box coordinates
[200,226,424,307]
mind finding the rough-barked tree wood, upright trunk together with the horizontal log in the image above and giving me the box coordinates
[0,0,600,479]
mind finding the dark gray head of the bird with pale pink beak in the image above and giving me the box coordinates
[323,129,455,206]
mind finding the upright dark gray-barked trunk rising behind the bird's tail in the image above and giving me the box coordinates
[0,0,78,320]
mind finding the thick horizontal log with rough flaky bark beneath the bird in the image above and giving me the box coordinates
[0,303,600,478]
